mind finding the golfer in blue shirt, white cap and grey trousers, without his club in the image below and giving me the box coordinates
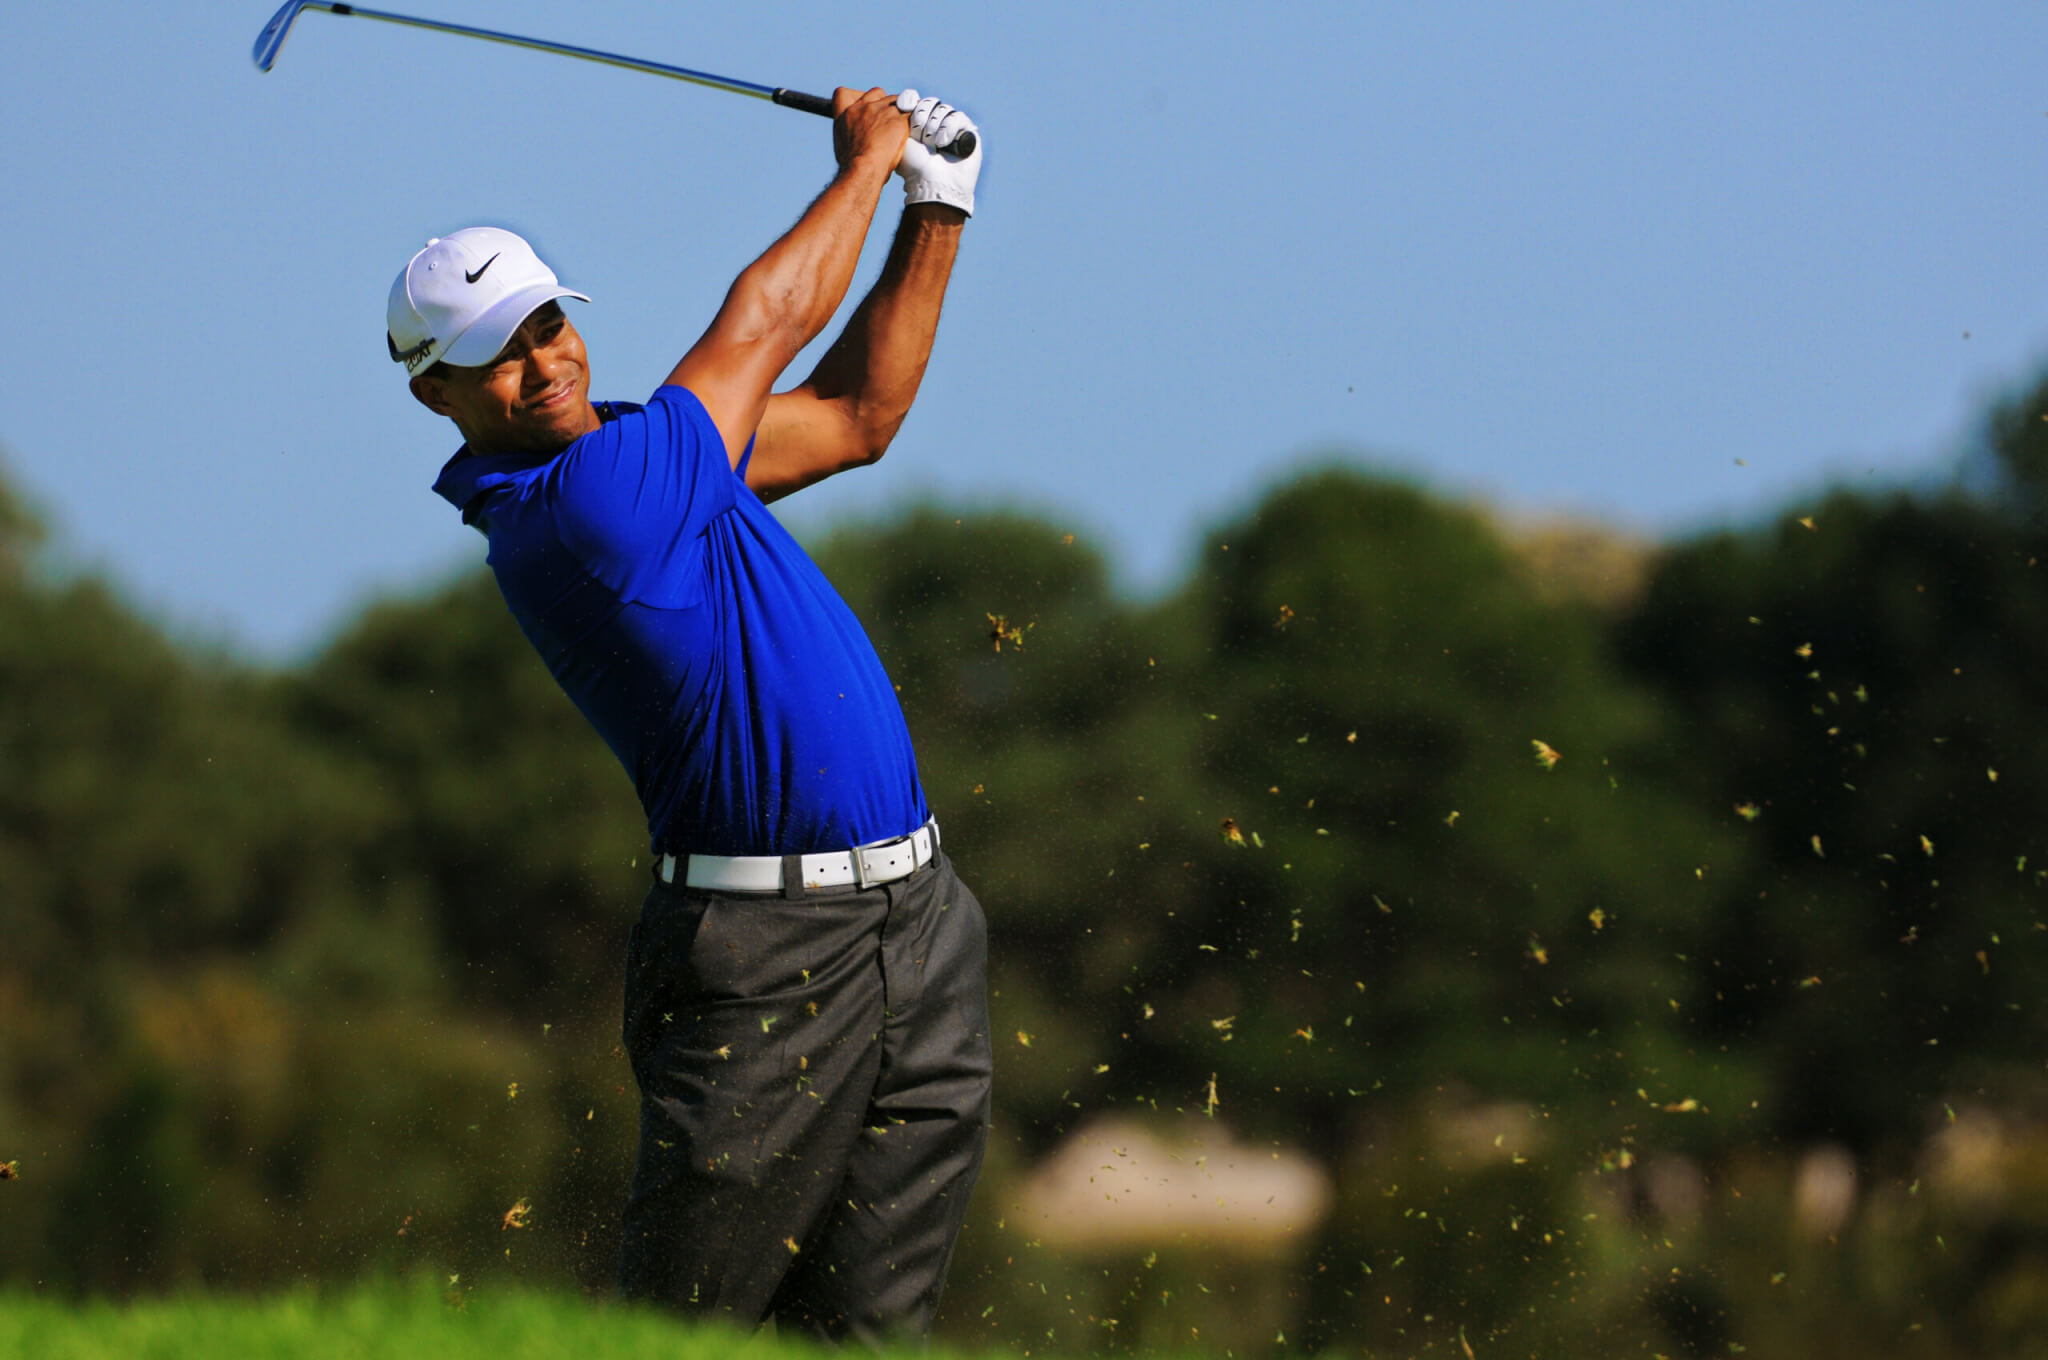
[387,90,989,1342]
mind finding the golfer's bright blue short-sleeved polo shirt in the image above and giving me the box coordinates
[434,387,928,854]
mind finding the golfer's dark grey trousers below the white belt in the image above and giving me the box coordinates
[621,854,991,1344]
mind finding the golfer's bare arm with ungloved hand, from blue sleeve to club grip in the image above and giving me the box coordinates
[668,88,909,465]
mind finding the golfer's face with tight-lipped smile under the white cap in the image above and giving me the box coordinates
[412,303,598,455]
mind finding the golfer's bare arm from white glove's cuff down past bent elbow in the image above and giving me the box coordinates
[748,203,967,500]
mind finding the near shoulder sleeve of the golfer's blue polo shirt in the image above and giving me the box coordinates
[549,387,739,608]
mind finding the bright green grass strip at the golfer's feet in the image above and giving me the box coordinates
[0,1284,958,1360]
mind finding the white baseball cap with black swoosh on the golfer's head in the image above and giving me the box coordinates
[385,227,590,377]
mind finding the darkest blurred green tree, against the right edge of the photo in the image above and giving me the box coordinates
[1620,494,2048,1153]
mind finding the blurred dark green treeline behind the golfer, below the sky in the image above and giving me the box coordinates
[0,374,2048,1358]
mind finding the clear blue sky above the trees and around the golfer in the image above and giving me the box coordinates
[0,0,2048,660]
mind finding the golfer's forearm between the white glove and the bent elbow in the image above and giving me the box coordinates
[805,203,967,457]
